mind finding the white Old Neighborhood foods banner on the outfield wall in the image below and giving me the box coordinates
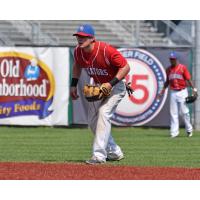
[0,47,70,125]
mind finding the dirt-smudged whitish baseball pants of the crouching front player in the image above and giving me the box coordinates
[88,81,126,161]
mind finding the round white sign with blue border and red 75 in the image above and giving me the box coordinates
[112,49,166,126]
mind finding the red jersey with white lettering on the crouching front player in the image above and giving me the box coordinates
[74,41,127,84]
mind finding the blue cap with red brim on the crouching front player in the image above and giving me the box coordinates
[73,24,95,37]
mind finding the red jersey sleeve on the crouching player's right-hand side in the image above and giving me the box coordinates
[107,46,127,68]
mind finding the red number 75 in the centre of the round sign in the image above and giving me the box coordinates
[126,74,149,104]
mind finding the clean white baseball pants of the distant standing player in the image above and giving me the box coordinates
[170,88,192,137]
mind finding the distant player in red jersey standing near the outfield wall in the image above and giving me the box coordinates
[160,52,197,138]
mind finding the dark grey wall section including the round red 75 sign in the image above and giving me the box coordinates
[71,48,192,127]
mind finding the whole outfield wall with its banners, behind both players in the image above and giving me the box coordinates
[0,47,192,126]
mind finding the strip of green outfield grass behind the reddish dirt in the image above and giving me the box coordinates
[0,127,200,167]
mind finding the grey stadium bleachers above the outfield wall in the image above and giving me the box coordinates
[0,20,177,47]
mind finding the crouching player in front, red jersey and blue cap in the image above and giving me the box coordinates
[70,24,130,164]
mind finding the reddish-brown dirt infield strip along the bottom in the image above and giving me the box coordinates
[0,162,200,180]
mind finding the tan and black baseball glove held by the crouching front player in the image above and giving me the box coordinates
[83,84,111,102]
